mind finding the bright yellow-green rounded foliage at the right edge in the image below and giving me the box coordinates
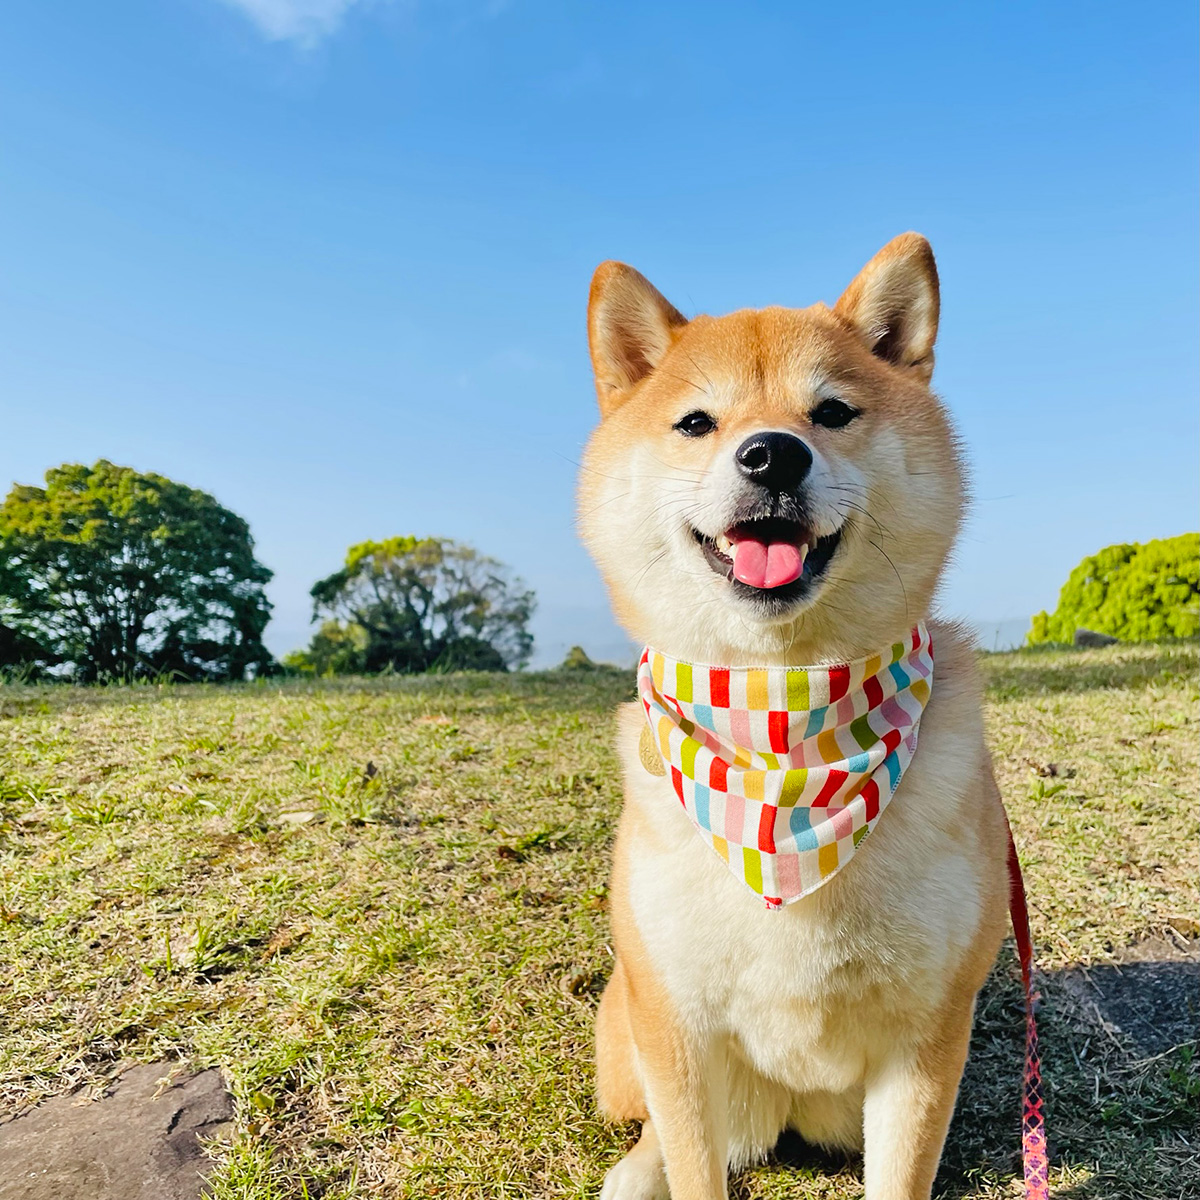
[1028,533,1200,644]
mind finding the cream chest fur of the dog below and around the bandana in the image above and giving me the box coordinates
[620,624,1002,1108]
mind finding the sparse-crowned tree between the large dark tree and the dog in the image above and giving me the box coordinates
[289,538,534,673]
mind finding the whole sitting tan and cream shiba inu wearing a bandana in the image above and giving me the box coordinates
[580,234,1007,1200]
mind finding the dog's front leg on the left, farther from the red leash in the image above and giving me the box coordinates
[634,1019,728,1200]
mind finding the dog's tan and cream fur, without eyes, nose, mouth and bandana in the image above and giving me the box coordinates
[580,234,1007,1200]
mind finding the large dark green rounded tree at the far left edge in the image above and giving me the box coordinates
[0,460,272,682]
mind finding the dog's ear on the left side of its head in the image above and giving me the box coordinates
[588,262,688,416]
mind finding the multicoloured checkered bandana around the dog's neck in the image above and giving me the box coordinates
[637,623,934,908]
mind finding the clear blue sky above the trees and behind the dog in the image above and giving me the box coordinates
[0,0,1200,661]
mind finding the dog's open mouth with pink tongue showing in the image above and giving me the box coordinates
[691,517,842,601]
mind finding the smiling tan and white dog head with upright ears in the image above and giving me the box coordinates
[580,234,964,666]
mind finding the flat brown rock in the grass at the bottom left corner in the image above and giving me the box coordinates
[0,1062,233,1200]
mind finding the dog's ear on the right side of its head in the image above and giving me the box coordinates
[833,233,940,383]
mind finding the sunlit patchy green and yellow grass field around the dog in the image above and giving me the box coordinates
[0,646,1200,1200]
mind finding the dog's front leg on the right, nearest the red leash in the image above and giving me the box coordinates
[863,1004,973,1200]
